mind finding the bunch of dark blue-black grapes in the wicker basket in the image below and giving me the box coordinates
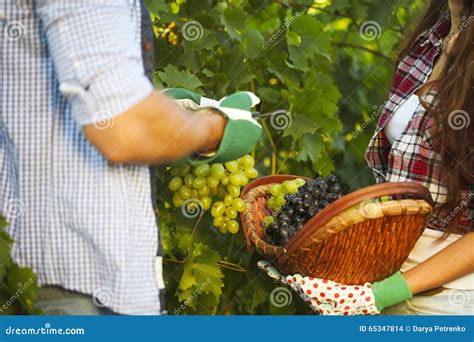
[264,175,342,246]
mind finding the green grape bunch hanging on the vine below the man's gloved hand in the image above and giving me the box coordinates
[168,155,258,234]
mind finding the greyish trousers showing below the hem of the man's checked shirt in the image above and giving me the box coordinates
[35,286,117,316]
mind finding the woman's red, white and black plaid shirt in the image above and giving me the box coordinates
[365,17,474,232]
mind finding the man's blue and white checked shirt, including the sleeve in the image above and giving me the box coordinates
[0,0,163,314]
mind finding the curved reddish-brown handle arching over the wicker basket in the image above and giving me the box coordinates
[285,182,434,252]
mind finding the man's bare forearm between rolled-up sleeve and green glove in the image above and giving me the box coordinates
[84,91,225,164]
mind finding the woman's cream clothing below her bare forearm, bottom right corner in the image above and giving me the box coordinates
[382,289,474,316]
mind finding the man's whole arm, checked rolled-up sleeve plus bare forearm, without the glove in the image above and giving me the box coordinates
[37,0,225,163]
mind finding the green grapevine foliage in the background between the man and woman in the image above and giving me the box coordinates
[147,0,424,314]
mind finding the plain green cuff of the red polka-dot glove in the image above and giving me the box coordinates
[372,272,413,311]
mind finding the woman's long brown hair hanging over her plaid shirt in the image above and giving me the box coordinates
[398,0,474,233]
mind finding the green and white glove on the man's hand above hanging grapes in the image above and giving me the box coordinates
[164,88,262,166]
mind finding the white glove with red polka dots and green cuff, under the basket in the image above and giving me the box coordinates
[258,261,412,316]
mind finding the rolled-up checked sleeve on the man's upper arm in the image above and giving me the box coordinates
[37,0,153,125]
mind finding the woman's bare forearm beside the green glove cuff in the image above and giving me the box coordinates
[403,233,474,294]
